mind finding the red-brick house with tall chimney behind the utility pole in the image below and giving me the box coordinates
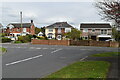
[6,20,35,37]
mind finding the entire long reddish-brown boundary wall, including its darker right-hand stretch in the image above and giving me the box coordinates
[31,39,119,47]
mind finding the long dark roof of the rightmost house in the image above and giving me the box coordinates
[80,23,112,28]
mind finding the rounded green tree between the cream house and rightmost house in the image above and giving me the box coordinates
[64,28,81,40]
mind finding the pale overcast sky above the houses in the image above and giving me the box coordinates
[0,1,108,28]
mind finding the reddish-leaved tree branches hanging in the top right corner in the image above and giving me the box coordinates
[96,0,120,27]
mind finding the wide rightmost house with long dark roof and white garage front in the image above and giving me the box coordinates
[80,23,112,41]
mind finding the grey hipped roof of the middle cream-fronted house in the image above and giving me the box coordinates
[46,22,73,28]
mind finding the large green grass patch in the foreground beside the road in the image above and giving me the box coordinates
[45,61,110,78]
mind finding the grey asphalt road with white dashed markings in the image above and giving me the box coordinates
[2,44,118,78]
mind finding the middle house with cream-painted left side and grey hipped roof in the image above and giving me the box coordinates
[45,22,73,40]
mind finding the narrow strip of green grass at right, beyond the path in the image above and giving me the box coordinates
[91,52,120,57]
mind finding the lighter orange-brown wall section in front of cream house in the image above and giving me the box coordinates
[31,39,69,46]
